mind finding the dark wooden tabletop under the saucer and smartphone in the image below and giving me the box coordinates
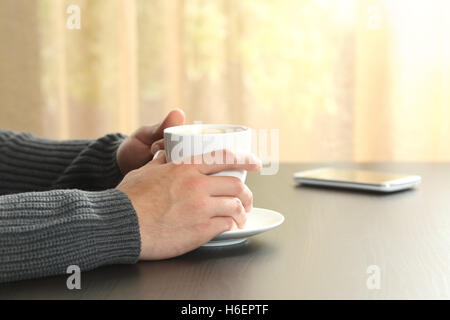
[0,163,450,299]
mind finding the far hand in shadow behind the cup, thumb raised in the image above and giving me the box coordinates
[117,109,185,175]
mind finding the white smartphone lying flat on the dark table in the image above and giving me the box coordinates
[294,168,422,192]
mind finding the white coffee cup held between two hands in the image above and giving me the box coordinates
[164,124,252,182]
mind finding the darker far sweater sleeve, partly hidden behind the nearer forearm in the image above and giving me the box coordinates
[0,130,125,195]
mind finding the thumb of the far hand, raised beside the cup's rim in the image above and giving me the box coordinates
[135,109,185,146]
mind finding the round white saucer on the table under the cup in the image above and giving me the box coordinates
[203,208,284,247]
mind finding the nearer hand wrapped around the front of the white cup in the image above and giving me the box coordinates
[117,151,261,260]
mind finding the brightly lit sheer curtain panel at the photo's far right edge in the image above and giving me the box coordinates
[354,0,450,161]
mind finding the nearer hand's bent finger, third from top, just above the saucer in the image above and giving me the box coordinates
[208,197,247,229]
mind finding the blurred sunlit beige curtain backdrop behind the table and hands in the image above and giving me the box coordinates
[0,0,450,162]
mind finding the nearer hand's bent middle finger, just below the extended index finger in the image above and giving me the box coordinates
[205,176,253,212]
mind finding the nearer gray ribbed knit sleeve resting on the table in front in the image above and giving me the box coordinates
[0,189,140,282]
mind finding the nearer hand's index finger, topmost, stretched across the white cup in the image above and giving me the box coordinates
[189,150,262,174]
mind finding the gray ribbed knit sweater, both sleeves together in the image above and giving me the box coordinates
[0,130,140,282]
